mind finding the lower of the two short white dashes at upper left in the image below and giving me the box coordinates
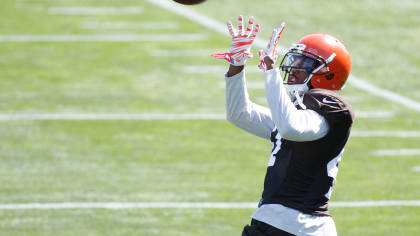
[81,21,179,29]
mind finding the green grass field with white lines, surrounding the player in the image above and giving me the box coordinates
[0,0,420,236]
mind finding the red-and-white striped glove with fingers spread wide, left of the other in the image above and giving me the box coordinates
[211,15,260,66]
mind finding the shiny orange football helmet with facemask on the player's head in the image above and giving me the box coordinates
[280,34,351,100]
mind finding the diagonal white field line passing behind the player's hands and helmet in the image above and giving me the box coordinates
[148,0,420,112]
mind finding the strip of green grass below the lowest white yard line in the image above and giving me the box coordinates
[0,207,419,236]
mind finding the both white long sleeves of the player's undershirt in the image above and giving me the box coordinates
[225,69,329,142]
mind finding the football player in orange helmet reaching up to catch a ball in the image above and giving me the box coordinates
[212,16,354,236]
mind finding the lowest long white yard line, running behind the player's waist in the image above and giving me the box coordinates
[0,200,420,210]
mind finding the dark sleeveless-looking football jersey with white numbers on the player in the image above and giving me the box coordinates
[260,89,354,216]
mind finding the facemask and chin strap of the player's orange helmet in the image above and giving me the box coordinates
[280,44,329,101]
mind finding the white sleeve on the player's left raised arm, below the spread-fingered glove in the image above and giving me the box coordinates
[225,69,275,139]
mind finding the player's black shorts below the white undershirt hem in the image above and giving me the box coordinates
[242,219,294,236]
